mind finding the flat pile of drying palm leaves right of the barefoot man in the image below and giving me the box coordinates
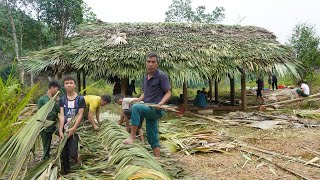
[160,118,234,155]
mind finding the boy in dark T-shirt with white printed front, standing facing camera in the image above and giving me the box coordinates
[59,76,86,173]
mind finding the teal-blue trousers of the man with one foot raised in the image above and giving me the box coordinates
[130,104,164,149]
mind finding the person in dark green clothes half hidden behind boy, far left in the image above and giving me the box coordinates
[37,80,60,159]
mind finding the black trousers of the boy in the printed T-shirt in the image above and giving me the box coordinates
[61,134,79,172]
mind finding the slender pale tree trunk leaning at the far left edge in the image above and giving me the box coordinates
[6,0,24,84]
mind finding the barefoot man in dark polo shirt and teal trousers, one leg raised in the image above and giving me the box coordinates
[124,52,171,157]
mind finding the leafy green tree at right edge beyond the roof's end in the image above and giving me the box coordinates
[290,23,320,78]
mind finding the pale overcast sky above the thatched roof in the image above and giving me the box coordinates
[84,0,320,43]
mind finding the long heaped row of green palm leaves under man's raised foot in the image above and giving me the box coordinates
[63,119,171,180]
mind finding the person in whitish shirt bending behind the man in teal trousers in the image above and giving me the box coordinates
[115,96,144,142]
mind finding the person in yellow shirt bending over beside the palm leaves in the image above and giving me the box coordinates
[84,95,111,131]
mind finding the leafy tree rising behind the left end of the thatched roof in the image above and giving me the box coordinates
[38,0,95,45]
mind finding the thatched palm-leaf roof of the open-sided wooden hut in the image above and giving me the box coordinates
[26,23,297,82]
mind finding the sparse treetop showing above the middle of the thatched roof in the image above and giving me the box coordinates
[165,0,225,23]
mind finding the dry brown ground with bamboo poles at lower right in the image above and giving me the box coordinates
[173,126,320,179]
